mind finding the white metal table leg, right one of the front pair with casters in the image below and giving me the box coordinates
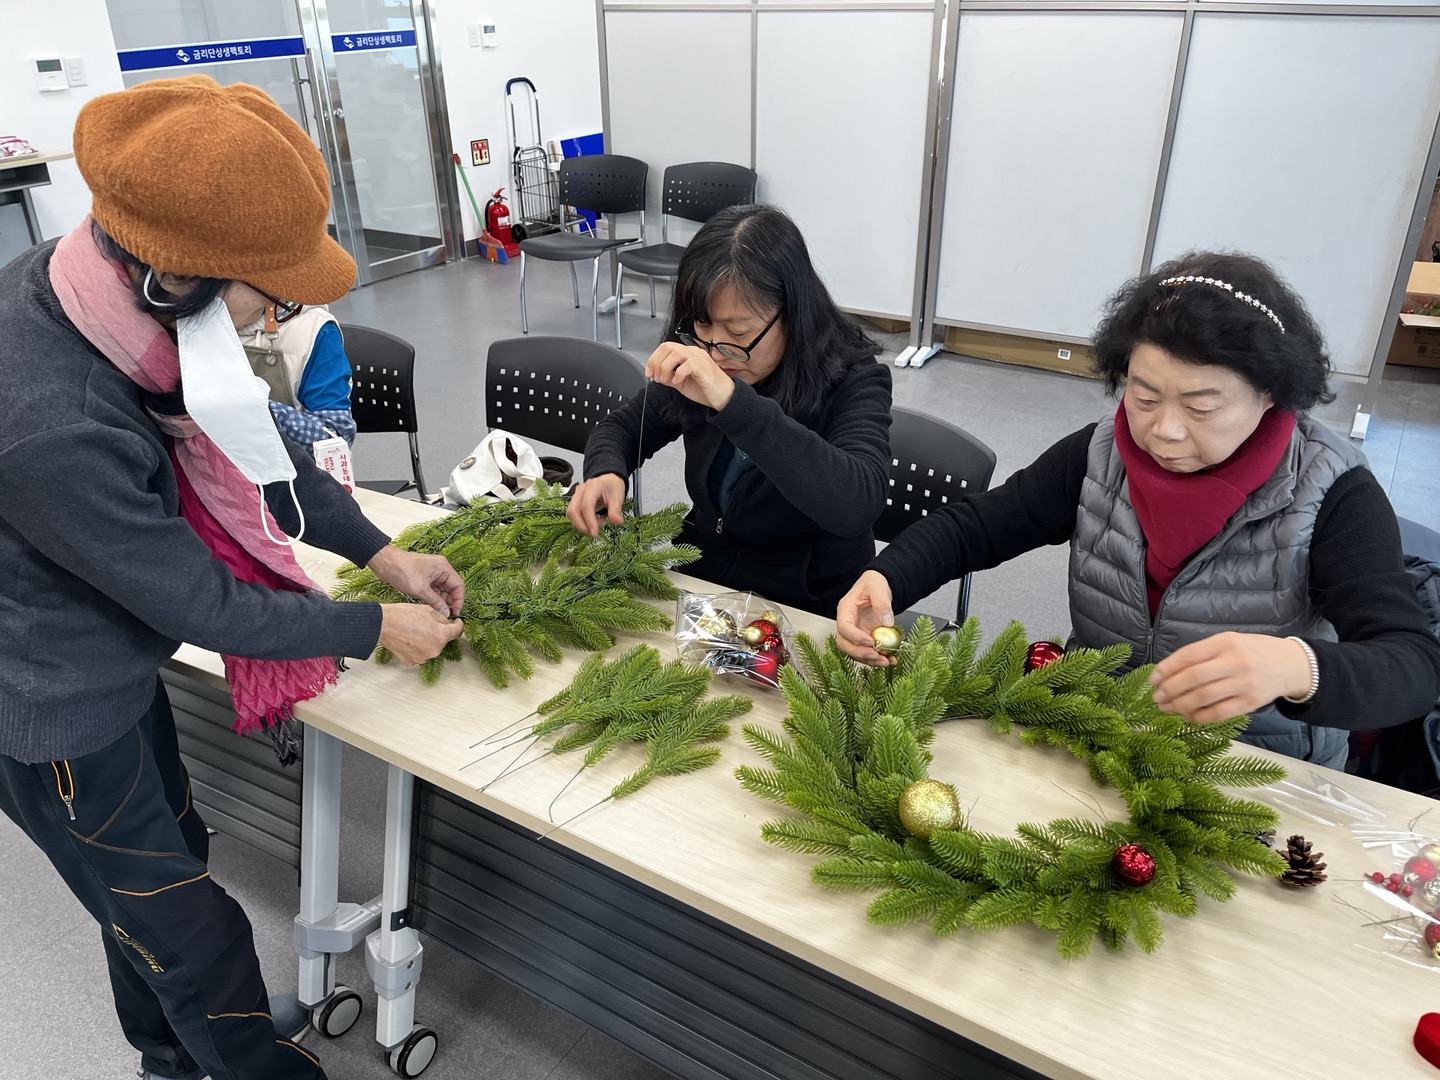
[366,765,433,1059]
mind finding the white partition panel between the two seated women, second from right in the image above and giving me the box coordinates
[936,12,1182,337]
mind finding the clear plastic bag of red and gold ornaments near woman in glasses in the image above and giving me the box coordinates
[675,592,795,687]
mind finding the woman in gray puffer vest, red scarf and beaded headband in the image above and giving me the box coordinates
[837,252,1440,769]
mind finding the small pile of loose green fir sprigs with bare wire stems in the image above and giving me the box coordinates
[485,645,752,812]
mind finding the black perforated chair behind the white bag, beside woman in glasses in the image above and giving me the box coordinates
[485,337,645,513]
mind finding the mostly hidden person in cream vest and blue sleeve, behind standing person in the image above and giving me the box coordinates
[240,297,356,446]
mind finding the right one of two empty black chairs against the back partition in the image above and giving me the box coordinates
[520,154,649,341]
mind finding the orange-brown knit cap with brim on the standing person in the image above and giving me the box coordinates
[75,75,356,304]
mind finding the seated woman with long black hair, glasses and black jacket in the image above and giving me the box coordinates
[570,206,890,615]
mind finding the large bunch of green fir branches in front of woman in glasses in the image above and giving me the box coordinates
[334,482,700,687]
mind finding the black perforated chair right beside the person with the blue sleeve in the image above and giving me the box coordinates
[340,324,428,503]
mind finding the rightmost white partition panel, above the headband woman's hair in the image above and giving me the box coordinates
[1155,13,1440,374]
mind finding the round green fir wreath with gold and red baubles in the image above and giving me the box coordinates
[737,618,1286,959]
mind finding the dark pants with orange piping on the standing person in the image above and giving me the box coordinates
[0,680,324,1080]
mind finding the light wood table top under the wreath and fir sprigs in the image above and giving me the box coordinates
[173,491,1440,1080]
